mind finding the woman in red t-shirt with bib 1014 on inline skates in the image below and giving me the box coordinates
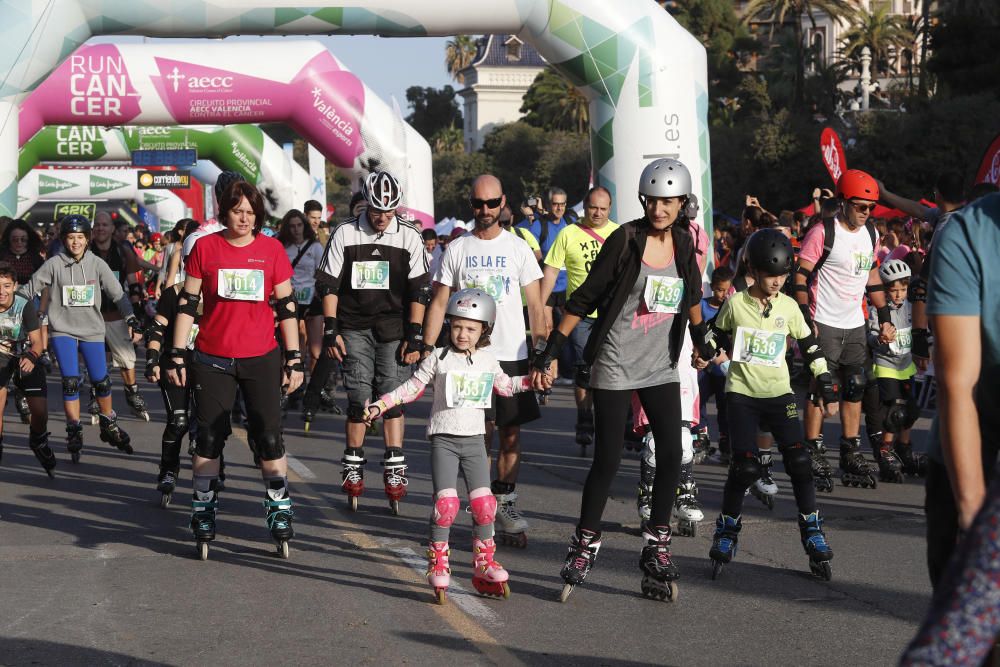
[168,182,302,560]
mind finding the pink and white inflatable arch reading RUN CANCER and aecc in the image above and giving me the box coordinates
[20,41,434,224]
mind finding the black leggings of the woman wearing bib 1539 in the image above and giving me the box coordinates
[580,382,681,532]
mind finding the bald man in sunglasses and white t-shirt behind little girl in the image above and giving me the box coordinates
[424,174,546,547]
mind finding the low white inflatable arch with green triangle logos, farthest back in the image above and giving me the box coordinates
[17,168,188,229]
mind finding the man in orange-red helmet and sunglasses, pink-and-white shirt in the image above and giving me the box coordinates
[795,169,896,491]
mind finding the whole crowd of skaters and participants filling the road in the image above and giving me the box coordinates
[0,158,1000,660]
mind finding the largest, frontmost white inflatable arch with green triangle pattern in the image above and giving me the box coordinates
[0,0,712,230]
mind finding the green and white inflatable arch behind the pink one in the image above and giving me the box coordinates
[17,125,312,217]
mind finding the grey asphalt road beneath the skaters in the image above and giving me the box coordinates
[0,377,930,666]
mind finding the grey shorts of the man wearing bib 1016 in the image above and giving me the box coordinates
[340,329,410,410]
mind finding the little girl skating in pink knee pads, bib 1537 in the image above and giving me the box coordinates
[365,289,544,604]
